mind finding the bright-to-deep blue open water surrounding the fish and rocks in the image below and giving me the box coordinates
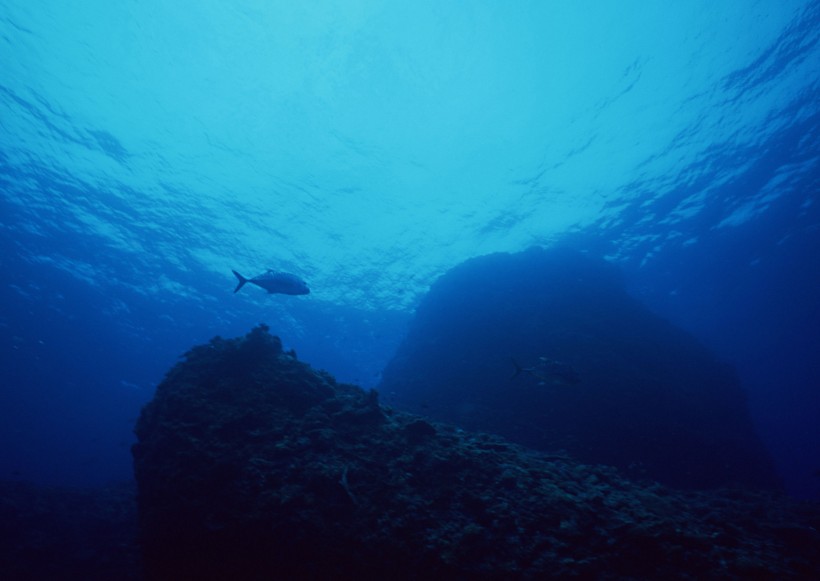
[0,0,820,498]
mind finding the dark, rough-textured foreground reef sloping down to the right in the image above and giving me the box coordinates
[133,326,820,581]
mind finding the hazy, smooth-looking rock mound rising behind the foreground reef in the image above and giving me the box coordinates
[379,249,779,488]
